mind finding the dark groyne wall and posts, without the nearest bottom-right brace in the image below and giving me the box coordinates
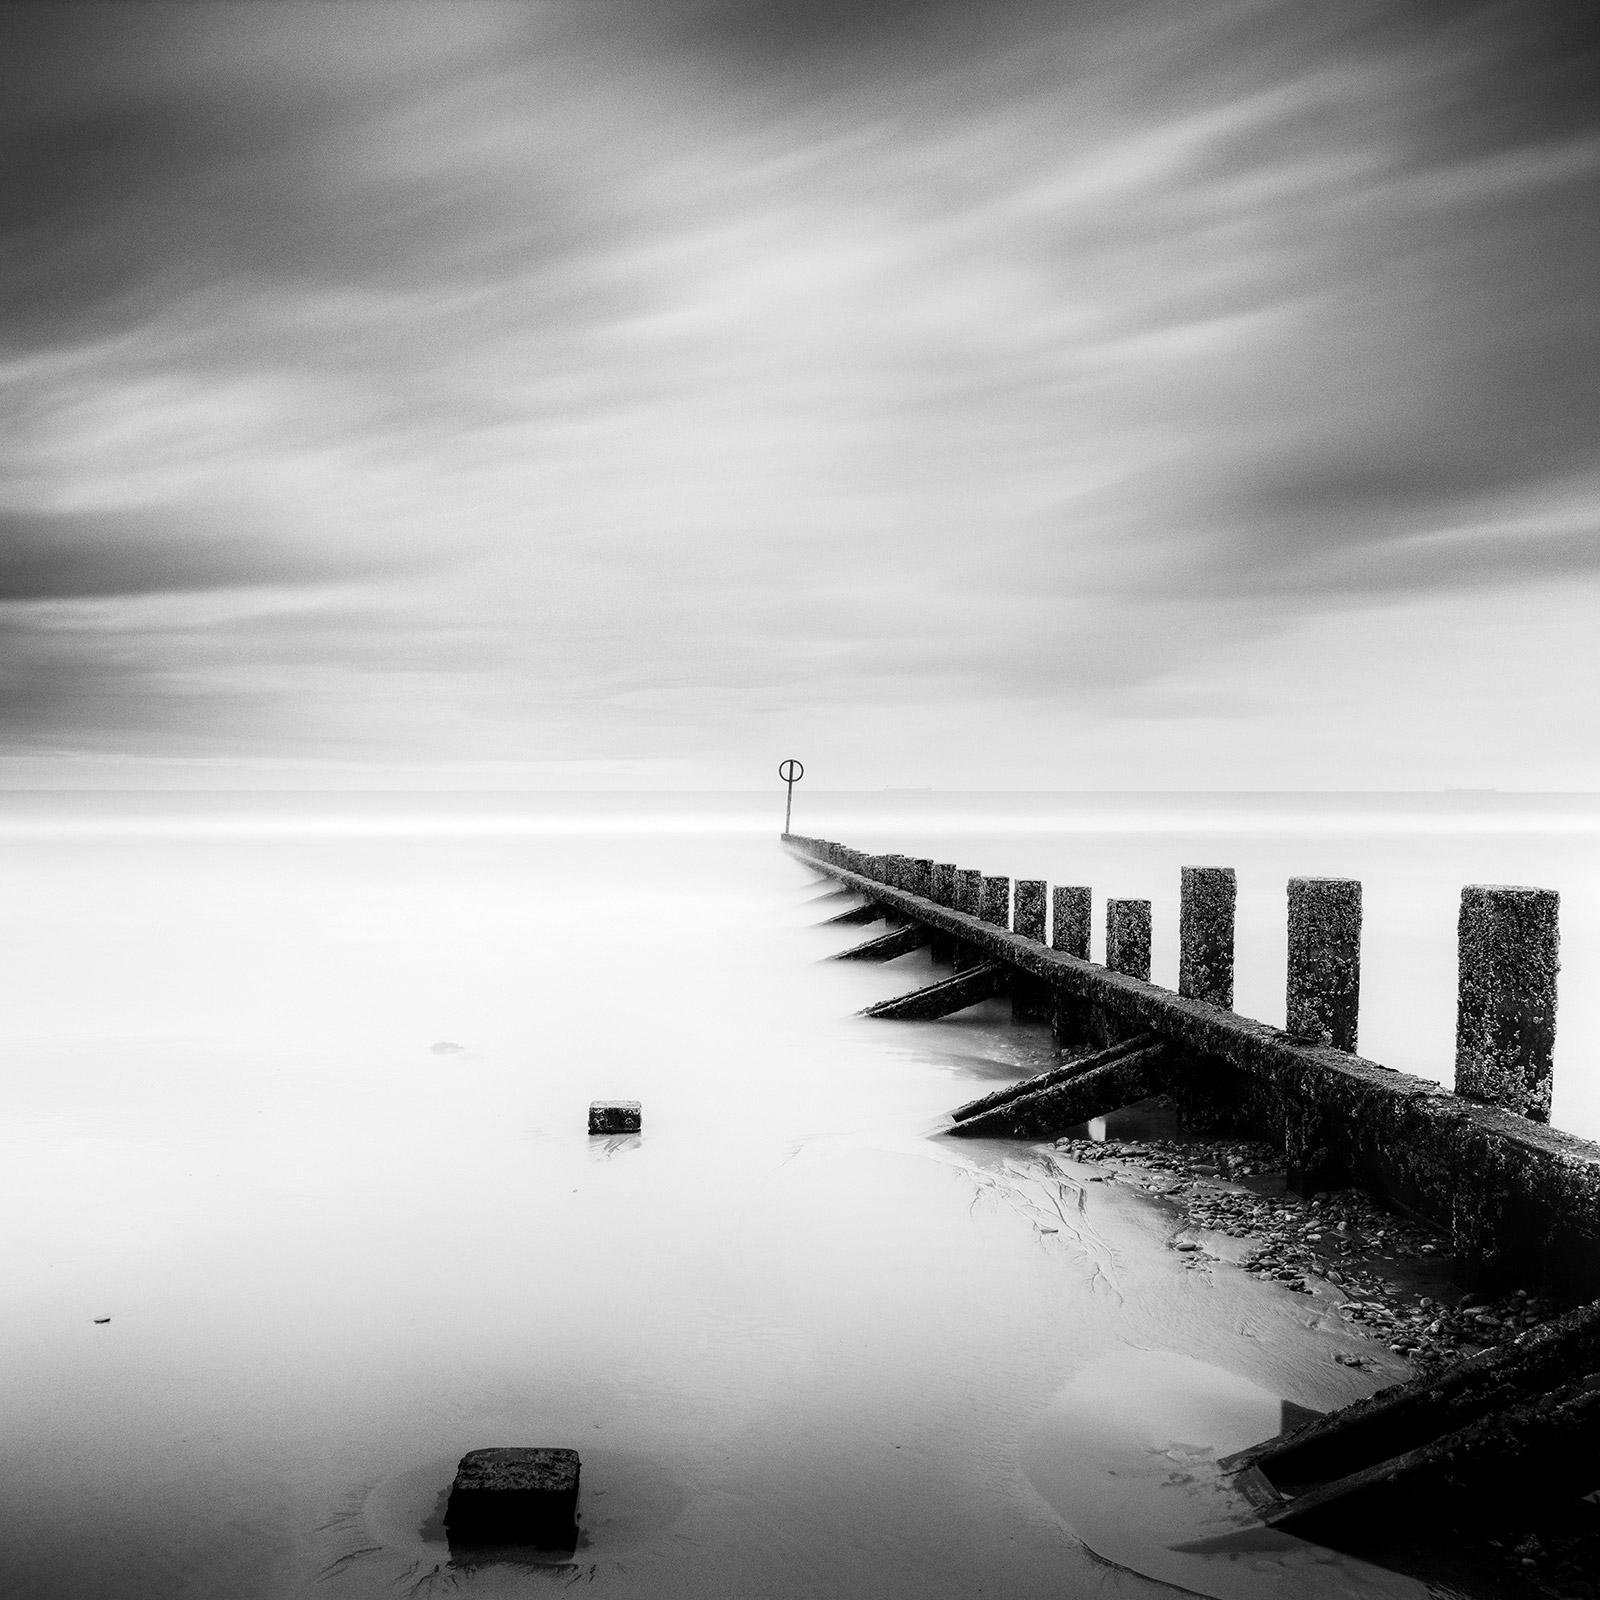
[784,835,1600,1298]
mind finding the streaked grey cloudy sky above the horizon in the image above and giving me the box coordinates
[0,0,1600,790]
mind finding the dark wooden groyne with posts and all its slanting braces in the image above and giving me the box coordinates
[784,835,1600,1547]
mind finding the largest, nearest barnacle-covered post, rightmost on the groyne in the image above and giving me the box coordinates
[1456,883,1560,1122]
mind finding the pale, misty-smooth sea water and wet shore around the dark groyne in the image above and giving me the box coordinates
[0,795,1600,1600]
